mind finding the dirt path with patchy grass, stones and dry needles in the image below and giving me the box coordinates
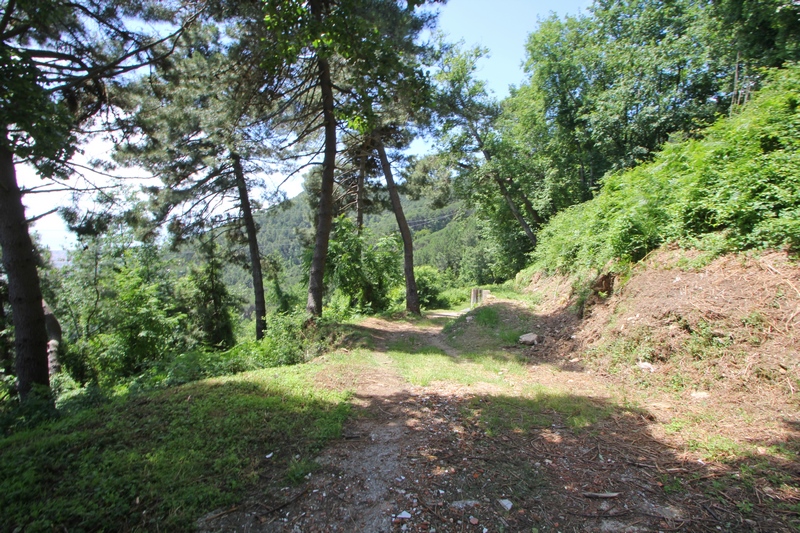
[200,300,790,533]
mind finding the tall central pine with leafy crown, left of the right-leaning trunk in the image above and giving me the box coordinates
[265,0,444,316]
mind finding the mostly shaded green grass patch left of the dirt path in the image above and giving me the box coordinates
[0,365,349,532]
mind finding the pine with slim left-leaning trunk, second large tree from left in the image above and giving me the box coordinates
[117,21,286,339]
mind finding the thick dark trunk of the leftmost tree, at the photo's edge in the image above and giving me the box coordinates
[0,139,50,400]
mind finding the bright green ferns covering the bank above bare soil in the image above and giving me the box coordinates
[533,65,800,273]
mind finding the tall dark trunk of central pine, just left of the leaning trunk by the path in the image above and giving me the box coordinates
[306,51,336,316]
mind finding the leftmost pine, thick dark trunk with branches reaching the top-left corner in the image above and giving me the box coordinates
[0,0,197,399]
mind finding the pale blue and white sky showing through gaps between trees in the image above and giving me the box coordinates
[17,0,592,250]
